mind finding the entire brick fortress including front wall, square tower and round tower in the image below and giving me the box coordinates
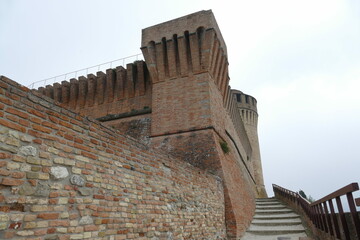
[0,11,266,240]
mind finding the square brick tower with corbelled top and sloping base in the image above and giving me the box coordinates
[141,11,266,239]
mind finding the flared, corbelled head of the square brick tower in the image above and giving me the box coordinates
[141,18,229,99]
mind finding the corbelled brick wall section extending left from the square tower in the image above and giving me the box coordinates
[37,61,151,118]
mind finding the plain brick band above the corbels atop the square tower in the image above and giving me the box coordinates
[141,10,227,55]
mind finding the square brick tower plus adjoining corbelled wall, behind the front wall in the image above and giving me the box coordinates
[24,11,262,239]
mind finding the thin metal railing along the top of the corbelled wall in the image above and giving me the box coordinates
[28,53,143,89]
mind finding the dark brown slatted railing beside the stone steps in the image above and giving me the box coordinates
[273,183,360,240]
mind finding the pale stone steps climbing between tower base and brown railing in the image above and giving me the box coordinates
[241,198,310,240]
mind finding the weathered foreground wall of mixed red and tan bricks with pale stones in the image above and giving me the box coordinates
[0,77,226,240]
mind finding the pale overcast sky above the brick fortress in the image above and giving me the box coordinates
[0,0,360,202]
